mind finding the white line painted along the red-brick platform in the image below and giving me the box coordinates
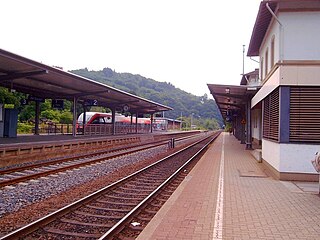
[213,134,225,240]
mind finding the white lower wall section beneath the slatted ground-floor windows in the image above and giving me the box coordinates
[262,139,320,174]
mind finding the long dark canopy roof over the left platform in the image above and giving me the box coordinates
[0,49,172,113]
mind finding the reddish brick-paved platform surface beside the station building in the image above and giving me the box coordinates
[138,133,320,240]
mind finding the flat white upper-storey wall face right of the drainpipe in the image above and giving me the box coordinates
[279,12,320,60]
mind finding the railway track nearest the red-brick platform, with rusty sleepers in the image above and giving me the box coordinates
[1,133,219,240]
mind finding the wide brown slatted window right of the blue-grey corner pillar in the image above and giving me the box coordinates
[289,86,320,143]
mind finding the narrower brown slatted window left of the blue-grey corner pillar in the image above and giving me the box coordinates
[263,88,280,142]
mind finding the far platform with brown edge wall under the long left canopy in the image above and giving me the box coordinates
[0,131,199,168]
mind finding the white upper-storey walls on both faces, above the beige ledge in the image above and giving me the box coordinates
[260,12,320,80]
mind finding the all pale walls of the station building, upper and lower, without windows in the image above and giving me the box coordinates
[255,8,320,177]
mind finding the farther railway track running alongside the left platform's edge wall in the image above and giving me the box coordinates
[0,136,200,187]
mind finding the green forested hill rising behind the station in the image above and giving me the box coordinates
[70,68,223,126]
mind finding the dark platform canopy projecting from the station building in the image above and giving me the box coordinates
[208,84,259,118]
